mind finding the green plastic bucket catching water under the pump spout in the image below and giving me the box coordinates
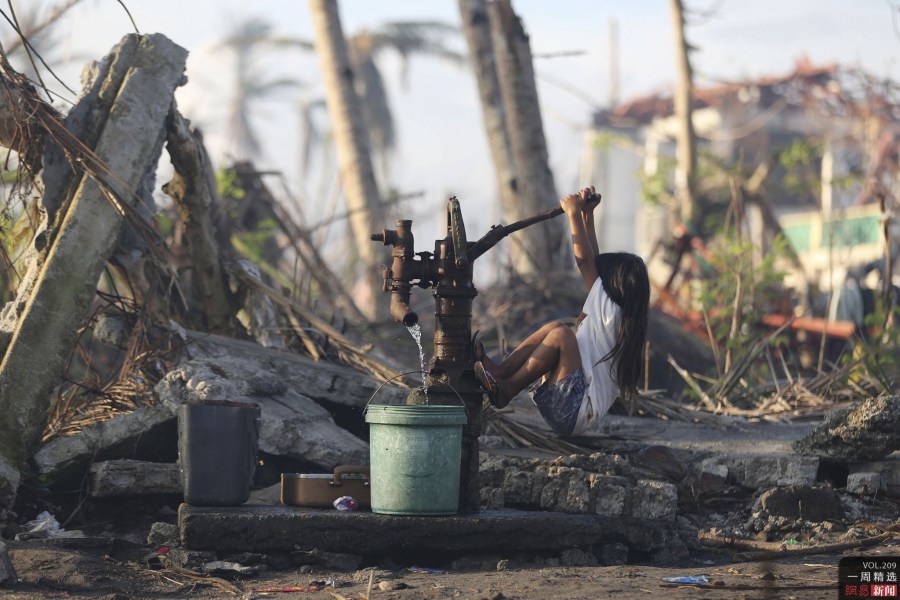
[366,404,466,515]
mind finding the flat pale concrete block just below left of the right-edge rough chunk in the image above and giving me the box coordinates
[704,454,819,489]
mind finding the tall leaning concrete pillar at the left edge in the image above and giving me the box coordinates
[0,34,187,506]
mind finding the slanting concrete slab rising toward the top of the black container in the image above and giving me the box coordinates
[32,404,175,475]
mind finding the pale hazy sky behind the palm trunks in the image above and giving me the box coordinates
[29,0,900,239]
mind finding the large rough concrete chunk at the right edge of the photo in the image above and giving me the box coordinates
[793,396,900,462]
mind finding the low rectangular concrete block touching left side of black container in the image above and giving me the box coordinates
[90,460,182,498]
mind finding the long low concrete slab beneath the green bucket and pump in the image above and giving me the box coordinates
[178,504,676,561]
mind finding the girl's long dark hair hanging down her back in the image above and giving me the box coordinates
[594,252,650,396]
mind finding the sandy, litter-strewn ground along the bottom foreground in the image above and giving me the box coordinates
[0,524,900,600]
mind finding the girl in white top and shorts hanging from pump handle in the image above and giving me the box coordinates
[475,187,650,436]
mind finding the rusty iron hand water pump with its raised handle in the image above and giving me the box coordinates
[372,197,562,513]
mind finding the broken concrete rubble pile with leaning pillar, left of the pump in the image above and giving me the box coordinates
[0,34,398,516]
